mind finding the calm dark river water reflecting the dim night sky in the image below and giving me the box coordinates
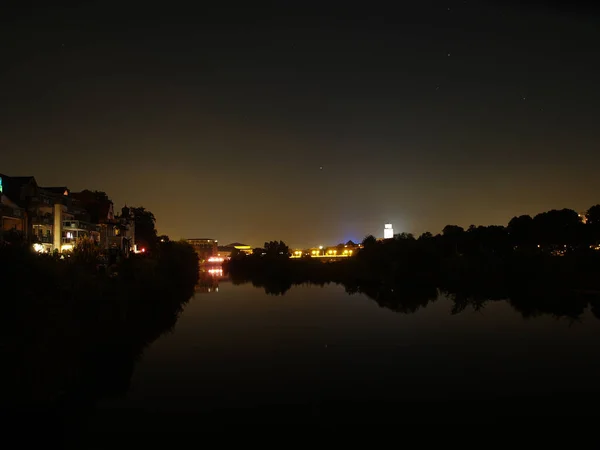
[89,272,600,427]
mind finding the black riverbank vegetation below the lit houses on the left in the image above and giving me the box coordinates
[0,239,199,438]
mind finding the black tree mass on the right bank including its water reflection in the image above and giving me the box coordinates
[225,205,600,317]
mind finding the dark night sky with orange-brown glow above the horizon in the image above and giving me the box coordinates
[0,1,600,246]
